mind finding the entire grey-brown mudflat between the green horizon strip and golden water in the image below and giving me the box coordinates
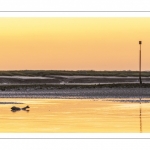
[0,72,150,99]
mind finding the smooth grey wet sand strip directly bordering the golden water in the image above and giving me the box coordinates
[0,88,150,99]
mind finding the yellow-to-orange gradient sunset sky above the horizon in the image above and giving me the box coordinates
[0,17,150,70]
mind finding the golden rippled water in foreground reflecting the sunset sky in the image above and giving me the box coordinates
[0,98,150,133]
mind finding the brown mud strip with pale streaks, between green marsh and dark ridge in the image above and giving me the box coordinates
[0,75,150,85]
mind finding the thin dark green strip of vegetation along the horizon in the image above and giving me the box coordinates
[0,70,150,77]
